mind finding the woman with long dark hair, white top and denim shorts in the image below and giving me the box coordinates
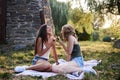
[14,24,58,72]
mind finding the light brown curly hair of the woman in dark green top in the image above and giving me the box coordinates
[62,24,77,41]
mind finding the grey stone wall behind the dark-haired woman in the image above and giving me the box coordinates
[6,0,51,45]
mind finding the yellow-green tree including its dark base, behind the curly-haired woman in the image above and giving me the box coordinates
[68,8,94,40]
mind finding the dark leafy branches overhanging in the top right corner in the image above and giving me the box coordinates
[86,0,120,14]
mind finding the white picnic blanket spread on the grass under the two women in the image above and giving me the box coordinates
[15,59,101,80]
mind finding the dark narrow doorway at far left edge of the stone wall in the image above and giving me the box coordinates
[0,0,7,44]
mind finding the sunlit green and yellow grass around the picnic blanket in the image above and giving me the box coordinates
[0,41,120,80]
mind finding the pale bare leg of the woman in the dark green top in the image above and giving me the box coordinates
[52,61,82,73]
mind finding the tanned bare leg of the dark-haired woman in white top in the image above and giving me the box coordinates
[26,60,52,71]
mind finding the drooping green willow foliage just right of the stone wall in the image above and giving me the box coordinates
[50,0,69,35]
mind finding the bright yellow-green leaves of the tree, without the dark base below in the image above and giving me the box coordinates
[68,8,94,34]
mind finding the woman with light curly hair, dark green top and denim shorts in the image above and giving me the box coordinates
[52,24,84,73]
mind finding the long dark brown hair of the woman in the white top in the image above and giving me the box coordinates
[35,24,48,54]
